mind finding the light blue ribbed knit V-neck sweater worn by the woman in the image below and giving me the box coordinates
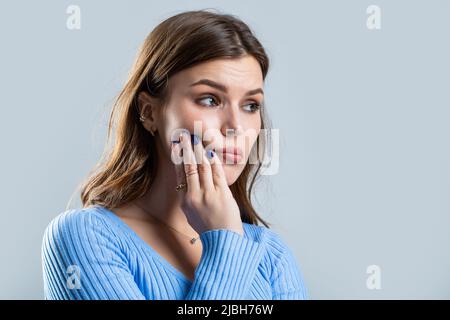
[42,205,307,300]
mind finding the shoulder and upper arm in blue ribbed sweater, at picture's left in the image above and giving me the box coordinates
[41,207,141,300]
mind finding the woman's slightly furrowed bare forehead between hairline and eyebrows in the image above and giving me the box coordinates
[170,56,264,94]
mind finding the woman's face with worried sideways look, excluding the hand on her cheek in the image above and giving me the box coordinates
[155,56,264,185]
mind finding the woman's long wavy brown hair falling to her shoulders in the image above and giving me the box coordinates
[77,9,270,228]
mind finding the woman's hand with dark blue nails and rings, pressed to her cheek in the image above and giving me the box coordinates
[172,132,244,235]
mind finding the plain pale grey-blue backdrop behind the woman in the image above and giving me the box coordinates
[0,0,450,299]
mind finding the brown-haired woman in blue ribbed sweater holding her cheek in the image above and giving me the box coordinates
[42,10,307,300]
